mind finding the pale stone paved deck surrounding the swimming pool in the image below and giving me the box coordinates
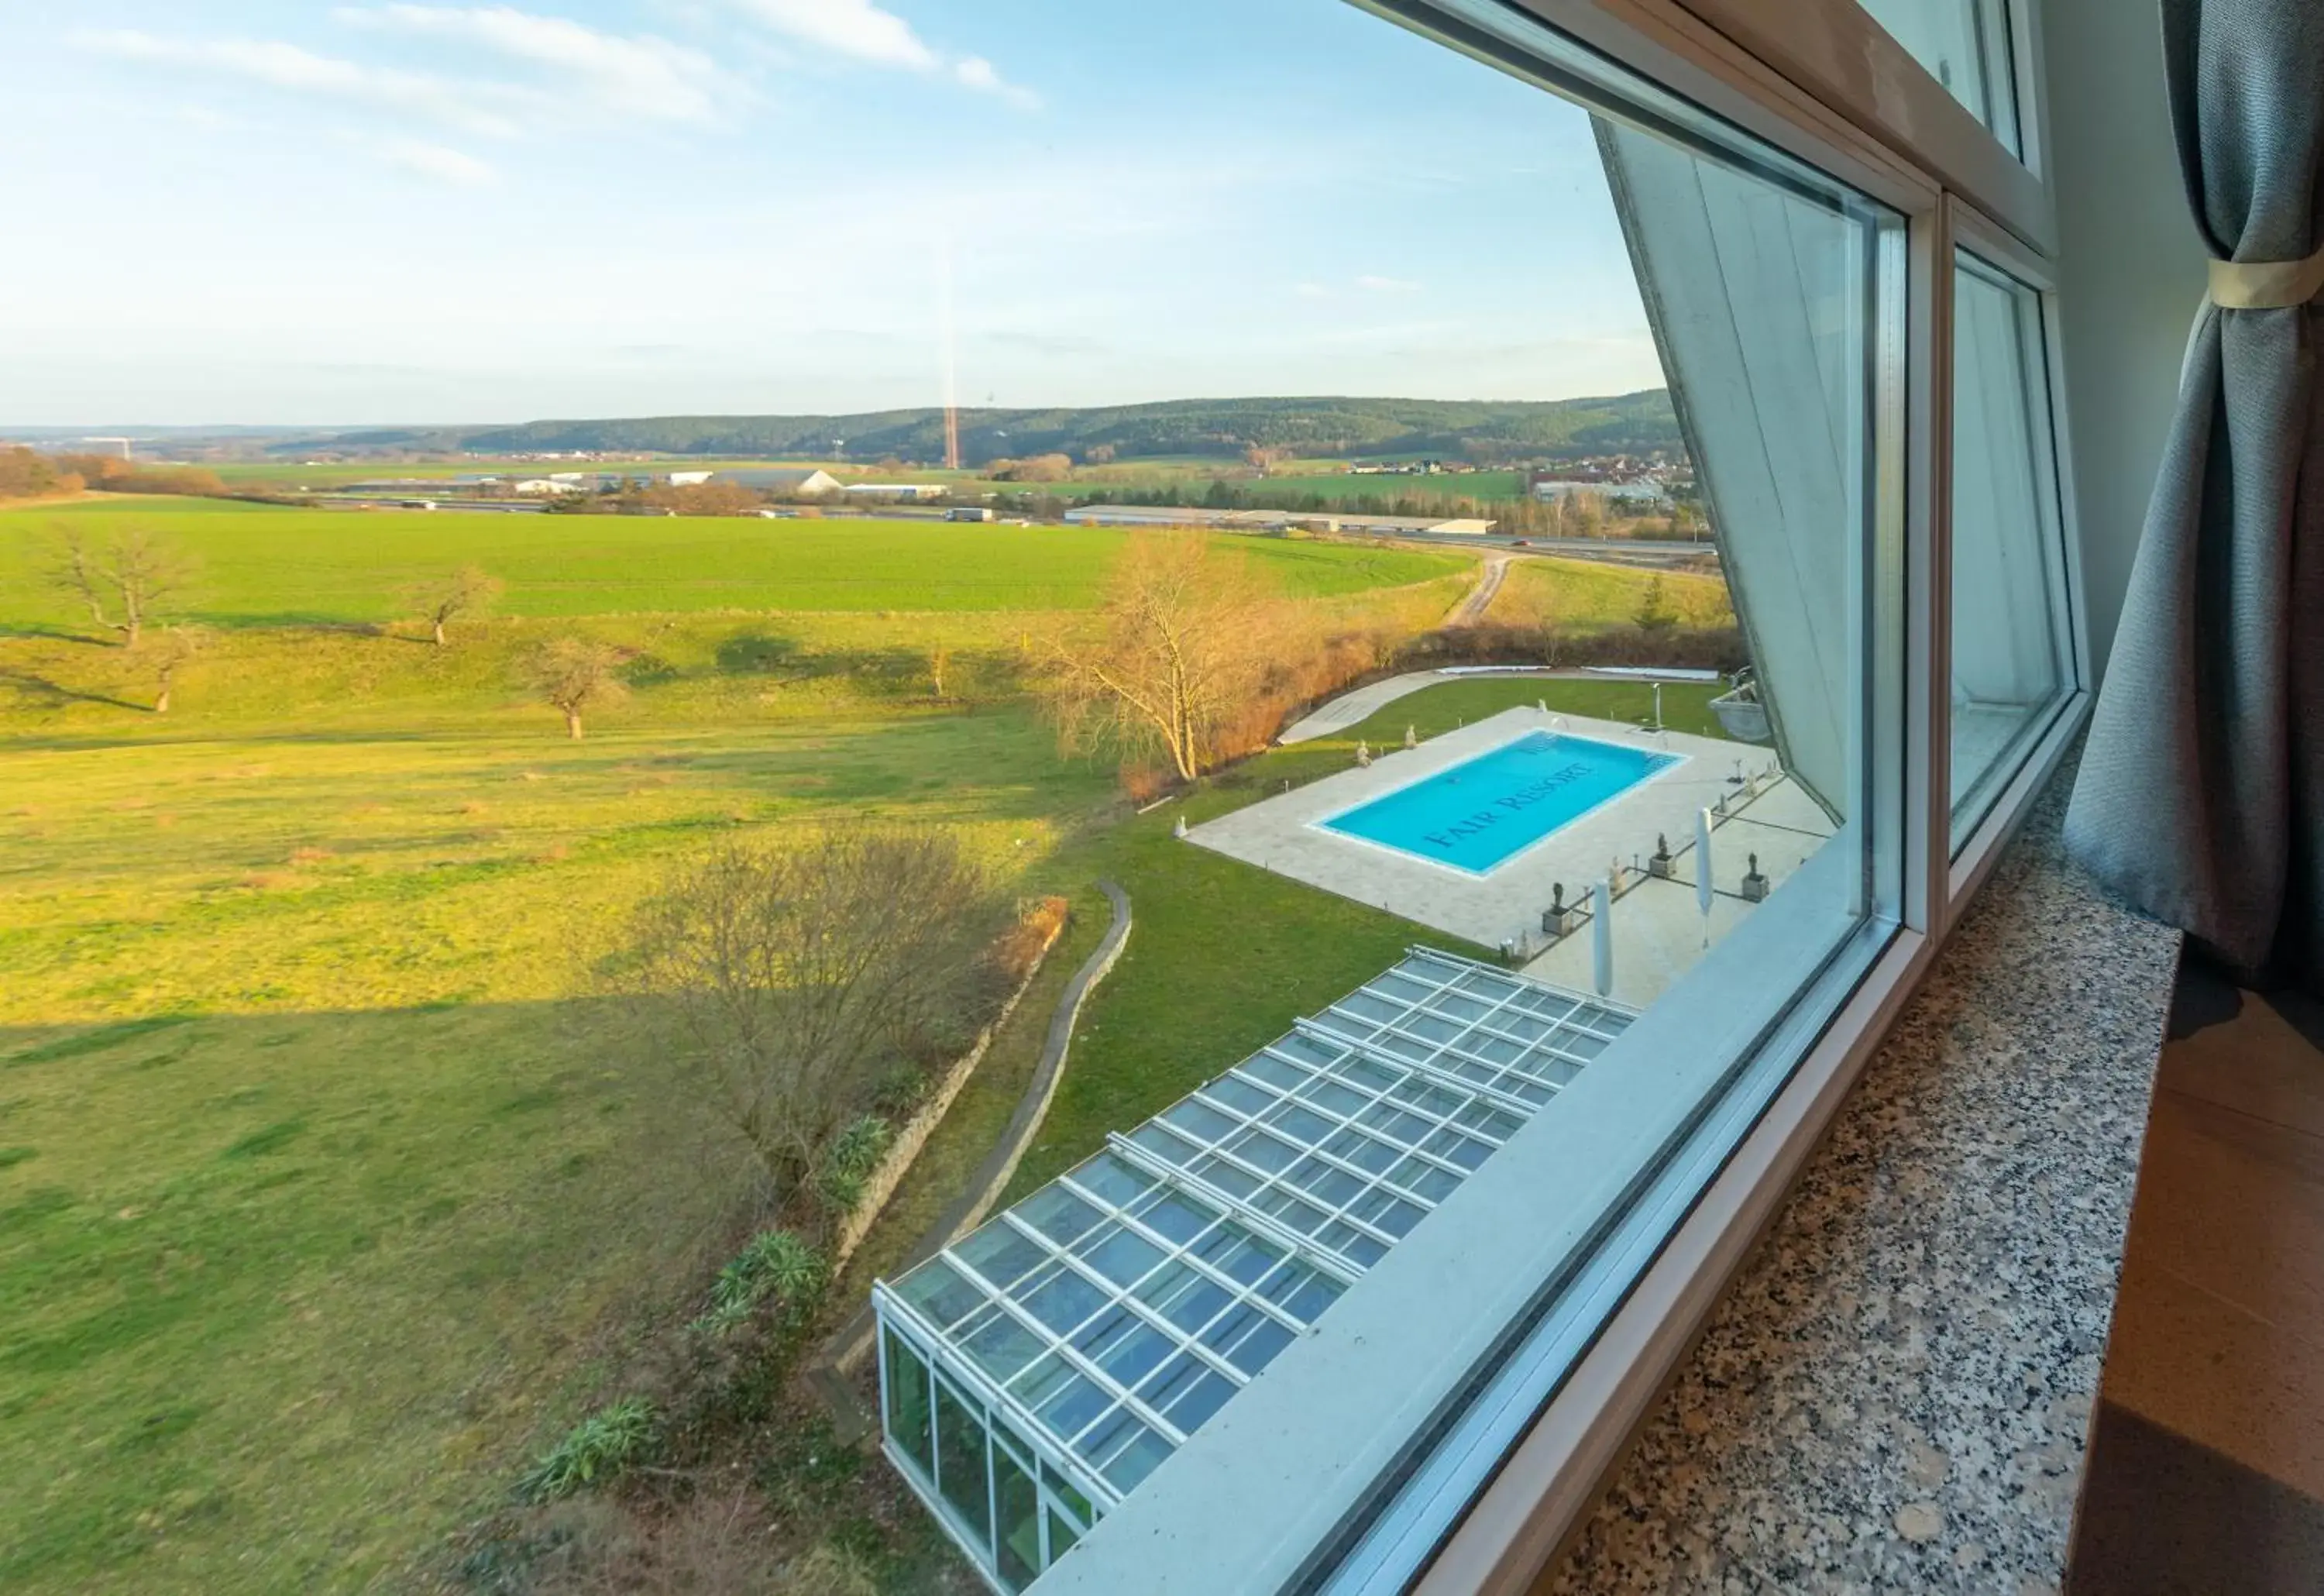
[1188,709,1785,975]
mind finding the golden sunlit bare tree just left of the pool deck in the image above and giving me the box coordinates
[1043,532,1278,781]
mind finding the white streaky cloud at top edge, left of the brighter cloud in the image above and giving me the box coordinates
[335,5,727,121]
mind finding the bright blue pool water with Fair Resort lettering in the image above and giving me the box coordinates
[1320,732,1680,875]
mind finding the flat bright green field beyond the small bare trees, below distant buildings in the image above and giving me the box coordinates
[0,497,1466,625]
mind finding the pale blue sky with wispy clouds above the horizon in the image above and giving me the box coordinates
[0,0,1662,425]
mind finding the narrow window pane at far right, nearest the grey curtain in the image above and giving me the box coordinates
[1952,256,2073,850]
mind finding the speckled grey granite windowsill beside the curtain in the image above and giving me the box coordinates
[1536,767,2180,1596]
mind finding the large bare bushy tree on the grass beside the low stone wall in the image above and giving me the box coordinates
[609,827,995,1201]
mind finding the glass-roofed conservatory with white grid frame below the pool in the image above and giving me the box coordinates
[874,948,1634,1591]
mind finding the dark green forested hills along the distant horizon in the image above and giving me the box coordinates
[318,388,1683,465]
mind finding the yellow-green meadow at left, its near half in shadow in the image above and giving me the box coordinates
[0,692,1111,1591]
